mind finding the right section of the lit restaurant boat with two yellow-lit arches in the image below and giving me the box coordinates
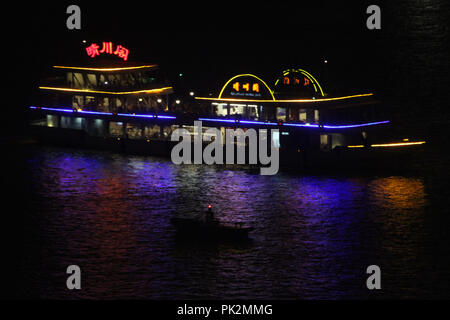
[195,68,425,170]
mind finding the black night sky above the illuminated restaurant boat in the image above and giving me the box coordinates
[3,0,448,138]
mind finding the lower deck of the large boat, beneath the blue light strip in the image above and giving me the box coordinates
[26,110,423,170]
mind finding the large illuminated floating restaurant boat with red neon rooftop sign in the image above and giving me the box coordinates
[29,42,425,168]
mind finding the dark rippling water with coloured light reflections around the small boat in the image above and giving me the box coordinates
[19,149,448,299]
